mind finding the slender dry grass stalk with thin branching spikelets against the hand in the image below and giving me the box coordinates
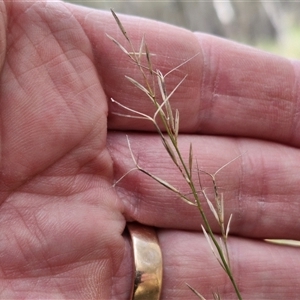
[107,11,242,300]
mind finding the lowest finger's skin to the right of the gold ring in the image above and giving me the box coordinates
[159,231,300,300]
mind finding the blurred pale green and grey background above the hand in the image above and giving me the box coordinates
[67,0,300,58]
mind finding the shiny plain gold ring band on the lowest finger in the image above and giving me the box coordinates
[127,223,163,300]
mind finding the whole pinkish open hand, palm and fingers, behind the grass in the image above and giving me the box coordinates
[0,1,300,300]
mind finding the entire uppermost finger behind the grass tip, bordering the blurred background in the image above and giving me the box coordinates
[74,6,300,145]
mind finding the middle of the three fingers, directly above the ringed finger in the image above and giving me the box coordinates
[108,133,300,239]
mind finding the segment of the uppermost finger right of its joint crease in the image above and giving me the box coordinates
[196,33,300,146]
